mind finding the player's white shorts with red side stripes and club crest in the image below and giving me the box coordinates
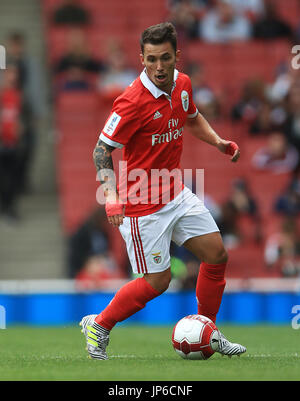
[119,187,219,274]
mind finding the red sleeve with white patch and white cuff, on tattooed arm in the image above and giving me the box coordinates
[99,98,140,149]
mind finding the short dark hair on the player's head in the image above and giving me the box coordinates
[140,22,177,54]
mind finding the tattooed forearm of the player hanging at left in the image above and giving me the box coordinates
[93,139,116,191]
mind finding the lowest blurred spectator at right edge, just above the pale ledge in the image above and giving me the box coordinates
[264,218,300,277]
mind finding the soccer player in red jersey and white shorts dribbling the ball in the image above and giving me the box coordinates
[80,22,246,359]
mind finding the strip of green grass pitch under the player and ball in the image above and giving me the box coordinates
[0,325,300,381]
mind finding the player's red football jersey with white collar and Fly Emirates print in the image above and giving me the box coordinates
[100,70,198,216]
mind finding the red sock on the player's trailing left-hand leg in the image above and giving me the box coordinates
[95,277,160,330]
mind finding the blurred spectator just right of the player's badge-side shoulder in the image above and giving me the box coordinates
[187,64,221,120]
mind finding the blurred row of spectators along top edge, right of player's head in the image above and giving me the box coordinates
[168,0,299,43]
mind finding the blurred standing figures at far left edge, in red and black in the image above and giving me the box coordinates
[0,32,44,224]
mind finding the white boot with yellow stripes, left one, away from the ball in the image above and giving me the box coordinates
[79,315,109,359]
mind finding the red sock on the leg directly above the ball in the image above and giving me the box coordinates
[196,262,226,322]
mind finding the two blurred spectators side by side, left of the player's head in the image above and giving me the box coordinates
[53,27,138,102]
